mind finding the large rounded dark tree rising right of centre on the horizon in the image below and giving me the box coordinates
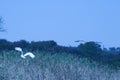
[78,41,102,59]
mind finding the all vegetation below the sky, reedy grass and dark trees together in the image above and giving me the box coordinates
[0,39,120,80]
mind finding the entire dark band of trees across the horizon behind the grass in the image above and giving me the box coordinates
[0,39,120,67]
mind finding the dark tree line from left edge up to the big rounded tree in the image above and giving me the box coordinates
[0,39,77,53]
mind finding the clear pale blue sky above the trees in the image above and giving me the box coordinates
[0,0,120,47]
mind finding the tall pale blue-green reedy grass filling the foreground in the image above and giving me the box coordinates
[0,51,120,80]
